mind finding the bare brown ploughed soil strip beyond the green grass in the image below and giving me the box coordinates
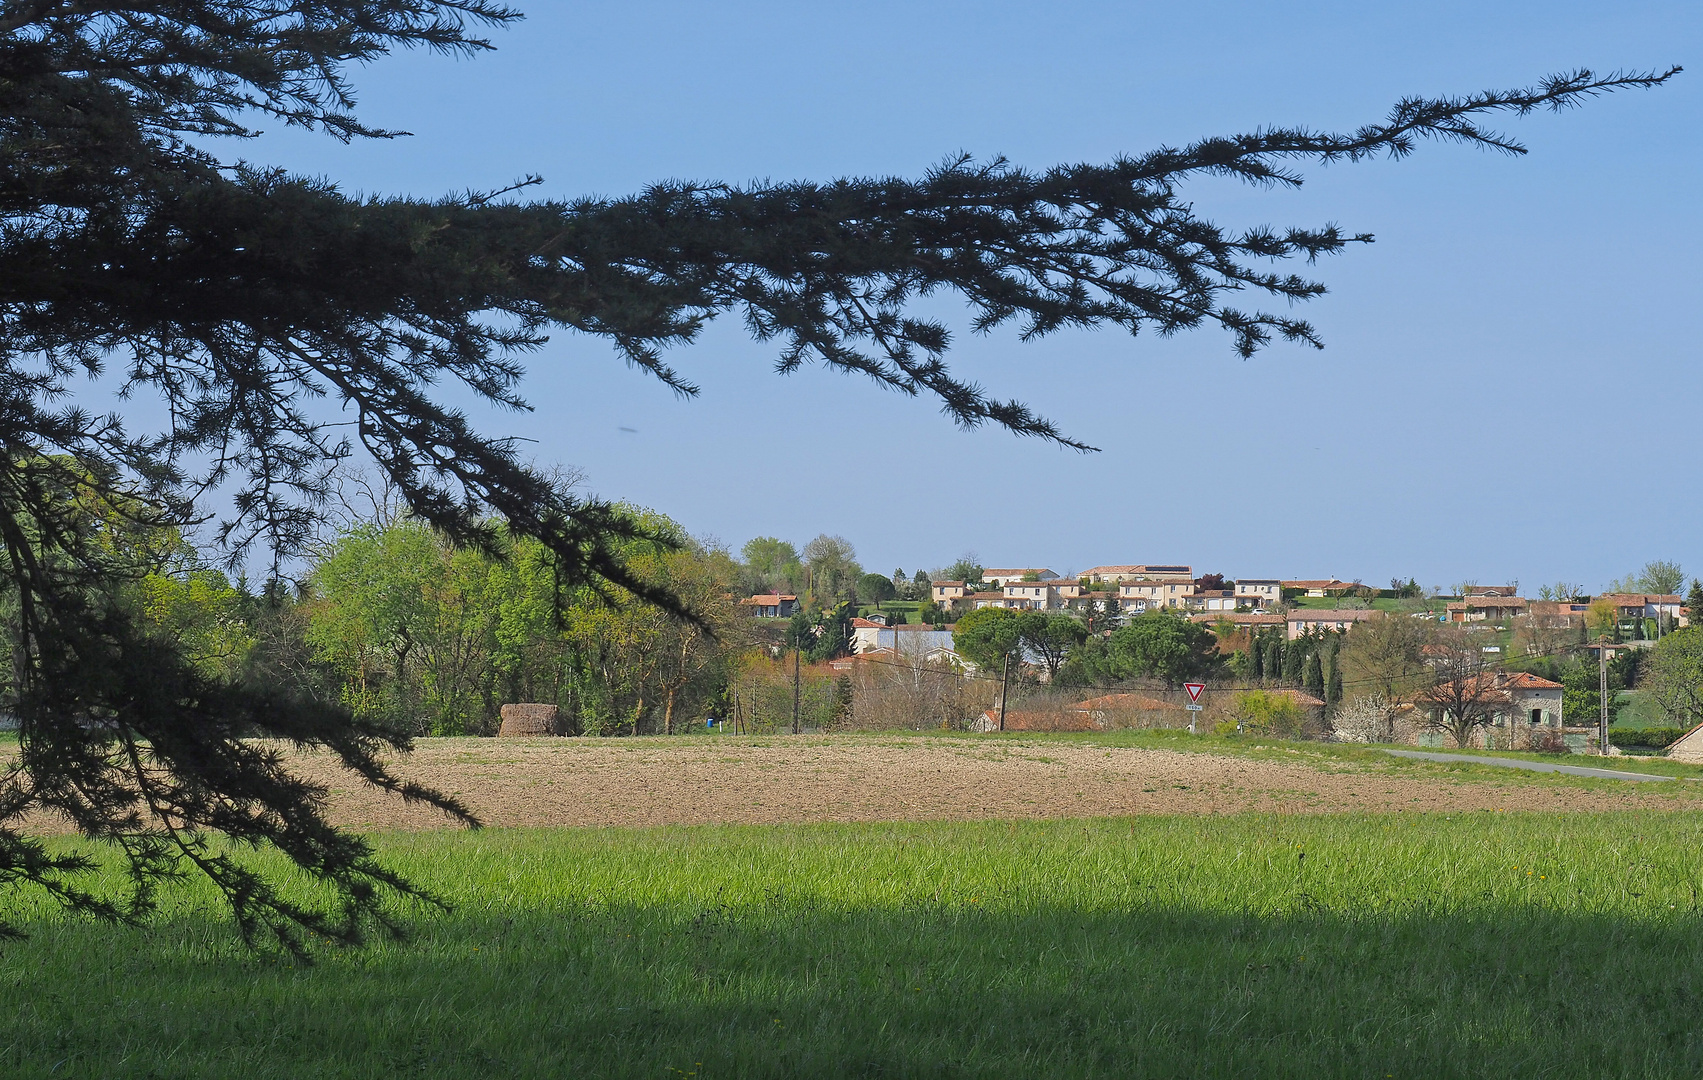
[275,736,1703,828]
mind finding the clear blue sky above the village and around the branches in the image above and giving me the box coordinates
[235,0,1703,591]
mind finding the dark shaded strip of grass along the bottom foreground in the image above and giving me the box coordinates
[0,893,1703,1080]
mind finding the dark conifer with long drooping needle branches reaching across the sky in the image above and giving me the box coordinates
[0,0,1677,952]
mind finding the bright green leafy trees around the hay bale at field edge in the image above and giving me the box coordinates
[307,511,732,734]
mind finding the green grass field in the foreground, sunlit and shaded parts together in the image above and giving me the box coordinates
[0,813,1703,1080]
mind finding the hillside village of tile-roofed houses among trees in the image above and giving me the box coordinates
[739,560,1703,753]
